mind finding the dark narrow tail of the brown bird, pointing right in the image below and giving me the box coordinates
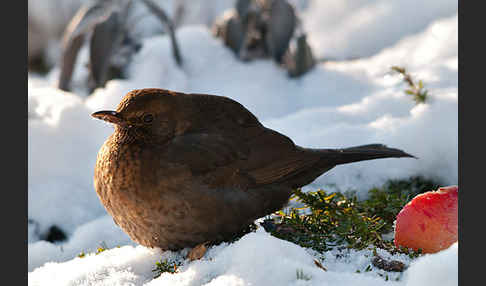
[319,144,416,165]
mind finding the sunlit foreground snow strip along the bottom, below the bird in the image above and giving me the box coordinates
[28,229,457,286]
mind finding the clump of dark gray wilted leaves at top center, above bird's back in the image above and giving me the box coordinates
[213,0,315,77]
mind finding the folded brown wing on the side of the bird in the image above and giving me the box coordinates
[166,128,319,187]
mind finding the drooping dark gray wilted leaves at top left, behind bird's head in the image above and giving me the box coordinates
[58,0,182,91]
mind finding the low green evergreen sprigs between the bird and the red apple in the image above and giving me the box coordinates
[264,177,439,258]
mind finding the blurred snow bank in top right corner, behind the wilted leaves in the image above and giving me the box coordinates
[303,0,458,59]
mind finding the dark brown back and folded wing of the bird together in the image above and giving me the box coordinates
[167,94,319,186]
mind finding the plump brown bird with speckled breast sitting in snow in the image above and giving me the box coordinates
[92,89,413,250]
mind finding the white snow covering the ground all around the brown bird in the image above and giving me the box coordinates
[28,0,458,286]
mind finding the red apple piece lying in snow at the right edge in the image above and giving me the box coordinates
[395,186,458,253]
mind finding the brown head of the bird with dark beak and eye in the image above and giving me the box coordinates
[91,88,182,142]
